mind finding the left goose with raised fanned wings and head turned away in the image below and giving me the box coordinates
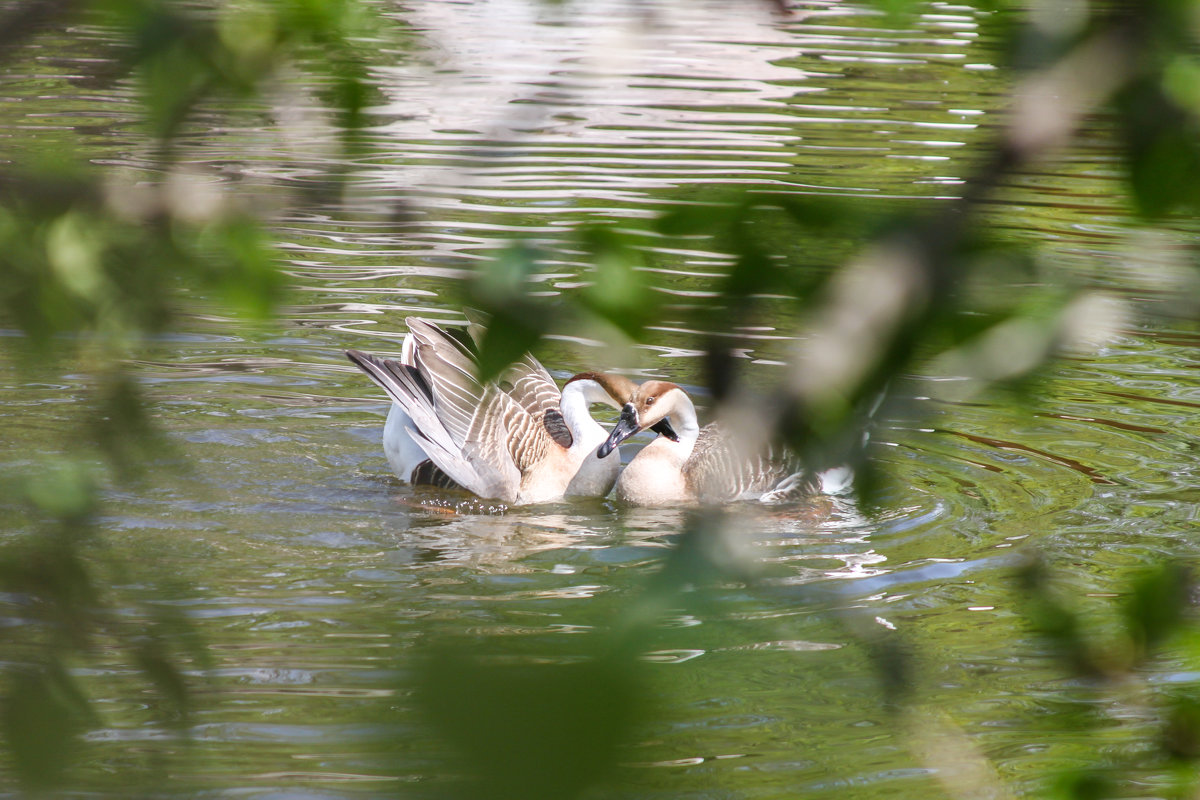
[346,318,674,505]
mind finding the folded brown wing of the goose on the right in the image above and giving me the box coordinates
[683,422,820,503]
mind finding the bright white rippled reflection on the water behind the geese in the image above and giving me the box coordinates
[272,0,983,345]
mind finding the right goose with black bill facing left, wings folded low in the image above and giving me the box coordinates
[596,380,821,506]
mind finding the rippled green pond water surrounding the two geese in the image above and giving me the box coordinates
[0,0,1200,799]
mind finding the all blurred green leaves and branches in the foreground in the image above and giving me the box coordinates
[0,0,1200,798]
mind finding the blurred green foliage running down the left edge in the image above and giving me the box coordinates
[0,0,395,793]
